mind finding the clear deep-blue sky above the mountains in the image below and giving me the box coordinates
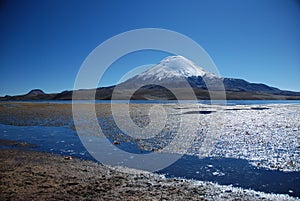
[0,0,300,96]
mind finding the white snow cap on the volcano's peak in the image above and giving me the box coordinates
[138,55,217,80]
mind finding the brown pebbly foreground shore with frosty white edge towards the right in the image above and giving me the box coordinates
[0,149,297,200]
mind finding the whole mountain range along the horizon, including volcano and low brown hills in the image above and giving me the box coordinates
[0,56,300,100]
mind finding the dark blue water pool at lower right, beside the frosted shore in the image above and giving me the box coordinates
[158,155,300,197]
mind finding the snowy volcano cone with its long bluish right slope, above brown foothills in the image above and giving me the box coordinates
[122,56,300,96]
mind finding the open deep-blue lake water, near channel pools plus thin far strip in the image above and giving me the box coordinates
[0,100,300,197]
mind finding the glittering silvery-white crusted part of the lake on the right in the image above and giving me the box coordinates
[91,104,300,171]
